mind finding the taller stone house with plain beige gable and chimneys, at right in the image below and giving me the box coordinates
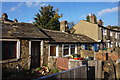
[70,14,120,49]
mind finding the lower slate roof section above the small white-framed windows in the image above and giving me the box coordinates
[41,29,96,43]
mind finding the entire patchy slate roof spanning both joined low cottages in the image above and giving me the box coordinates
[1,23,95,43]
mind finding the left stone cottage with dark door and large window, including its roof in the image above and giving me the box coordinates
[0,23,48,69]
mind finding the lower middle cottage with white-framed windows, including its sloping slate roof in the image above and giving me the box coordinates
[40,29,96,68]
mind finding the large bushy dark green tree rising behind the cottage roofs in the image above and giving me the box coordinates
[34,5,62,30]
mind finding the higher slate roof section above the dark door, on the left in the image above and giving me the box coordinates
[0,23,48,39]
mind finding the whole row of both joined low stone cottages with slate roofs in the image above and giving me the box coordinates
[0,19,96,69]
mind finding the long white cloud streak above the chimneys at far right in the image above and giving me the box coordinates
[97,7,120,17]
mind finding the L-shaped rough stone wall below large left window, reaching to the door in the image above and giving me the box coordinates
[2,40,30,69]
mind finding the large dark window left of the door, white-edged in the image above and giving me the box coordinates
[2,41,17,60]
